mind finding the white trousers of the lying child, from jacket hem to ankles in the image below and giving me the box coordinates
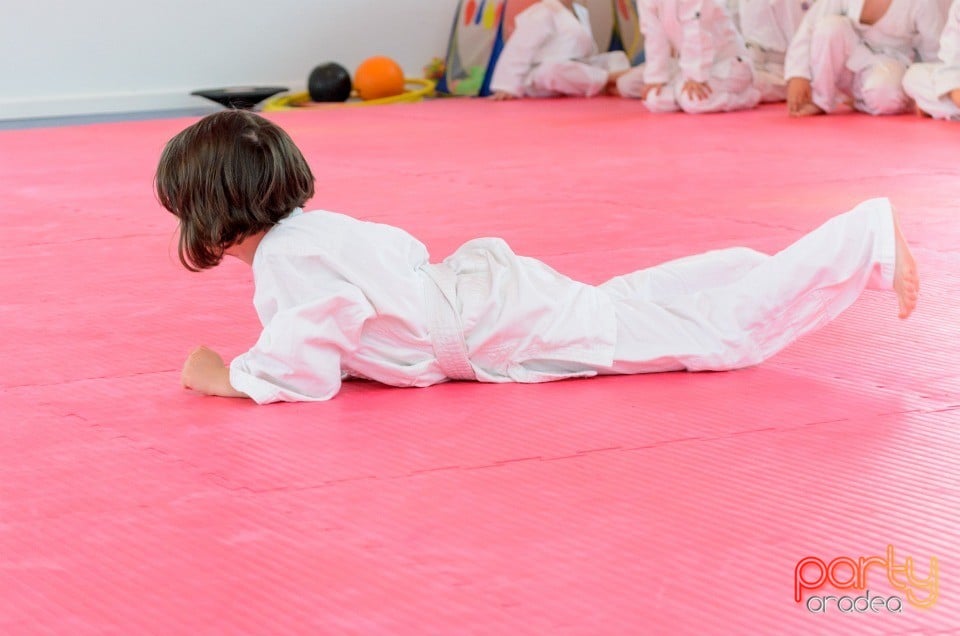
[596,199,896,374]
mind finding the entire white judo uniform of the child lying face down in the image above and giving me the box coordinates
[230,199,895,404]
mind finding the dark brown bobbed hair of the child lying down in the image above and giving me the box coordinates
[156,110,314,271]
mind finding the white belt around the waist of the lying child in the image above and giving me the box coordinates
[422,263,477,380]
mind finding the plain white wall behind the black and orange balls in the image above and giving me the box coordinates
[0,0,458,119]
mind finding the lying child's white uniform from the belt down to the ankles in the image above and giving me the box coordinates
[424,199,896,382]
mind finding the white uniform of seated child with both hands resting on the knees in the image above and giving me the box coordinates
[617,0,760,113]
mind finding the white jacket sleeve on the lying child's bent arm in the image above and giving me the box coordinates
[230,283,374,404]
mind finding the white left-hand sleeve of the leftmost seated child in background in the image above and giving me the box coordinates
[490,3,553,97]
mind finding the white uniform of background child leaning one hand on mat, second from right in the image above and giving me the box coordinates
[784,0,943,115]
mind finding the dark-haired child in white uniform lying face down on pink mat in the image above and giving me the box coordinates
[156,111,919,403]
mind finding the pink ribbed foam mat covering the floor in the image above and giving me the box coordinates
[0,99,960,635]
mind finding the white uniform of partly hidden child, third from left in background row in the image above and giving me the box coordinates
[731,0,813,102]
